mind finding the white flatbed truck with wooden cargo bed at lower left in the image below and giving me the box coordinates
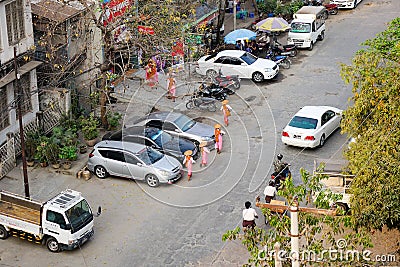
[0,189,101,252]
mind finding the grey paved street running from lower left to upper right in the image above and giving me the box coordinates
[0,0,400,267]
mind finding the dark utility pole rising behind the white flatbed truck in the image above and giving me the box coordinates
[14,46,30,199]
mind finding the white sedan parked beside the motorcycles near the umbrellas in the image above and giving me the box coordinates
[196,50,279,82]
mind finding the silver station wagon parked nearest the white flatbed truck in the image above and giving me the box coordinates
[87,140,183,187]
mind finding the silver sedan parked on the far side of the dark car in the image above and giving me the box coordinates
[134,111,214,149]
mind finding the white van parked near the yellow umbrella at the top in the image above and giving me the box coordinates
[288,6,328,50]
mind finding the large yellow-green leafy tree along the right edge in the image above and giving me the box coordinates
[341,18,400,229]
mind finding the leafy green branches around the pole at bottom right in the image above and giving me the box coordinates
[222,166,372,266]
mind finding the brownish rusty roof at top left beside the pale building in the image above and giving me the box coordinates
[31,0,82,23]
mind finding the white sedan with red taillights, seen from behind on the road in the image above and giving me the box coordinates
[282,106,343,148]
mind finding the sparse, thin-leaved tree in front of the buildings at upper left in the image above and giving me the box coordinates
[36,0,194,127]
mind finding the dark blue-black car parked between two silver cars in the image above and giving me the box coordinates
[103,126,199,161]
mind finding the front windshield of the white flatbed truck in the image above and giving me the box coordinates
[65,199,93,233]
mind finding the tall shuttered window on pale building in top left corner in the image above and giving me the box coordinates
[6,0,25,45]
